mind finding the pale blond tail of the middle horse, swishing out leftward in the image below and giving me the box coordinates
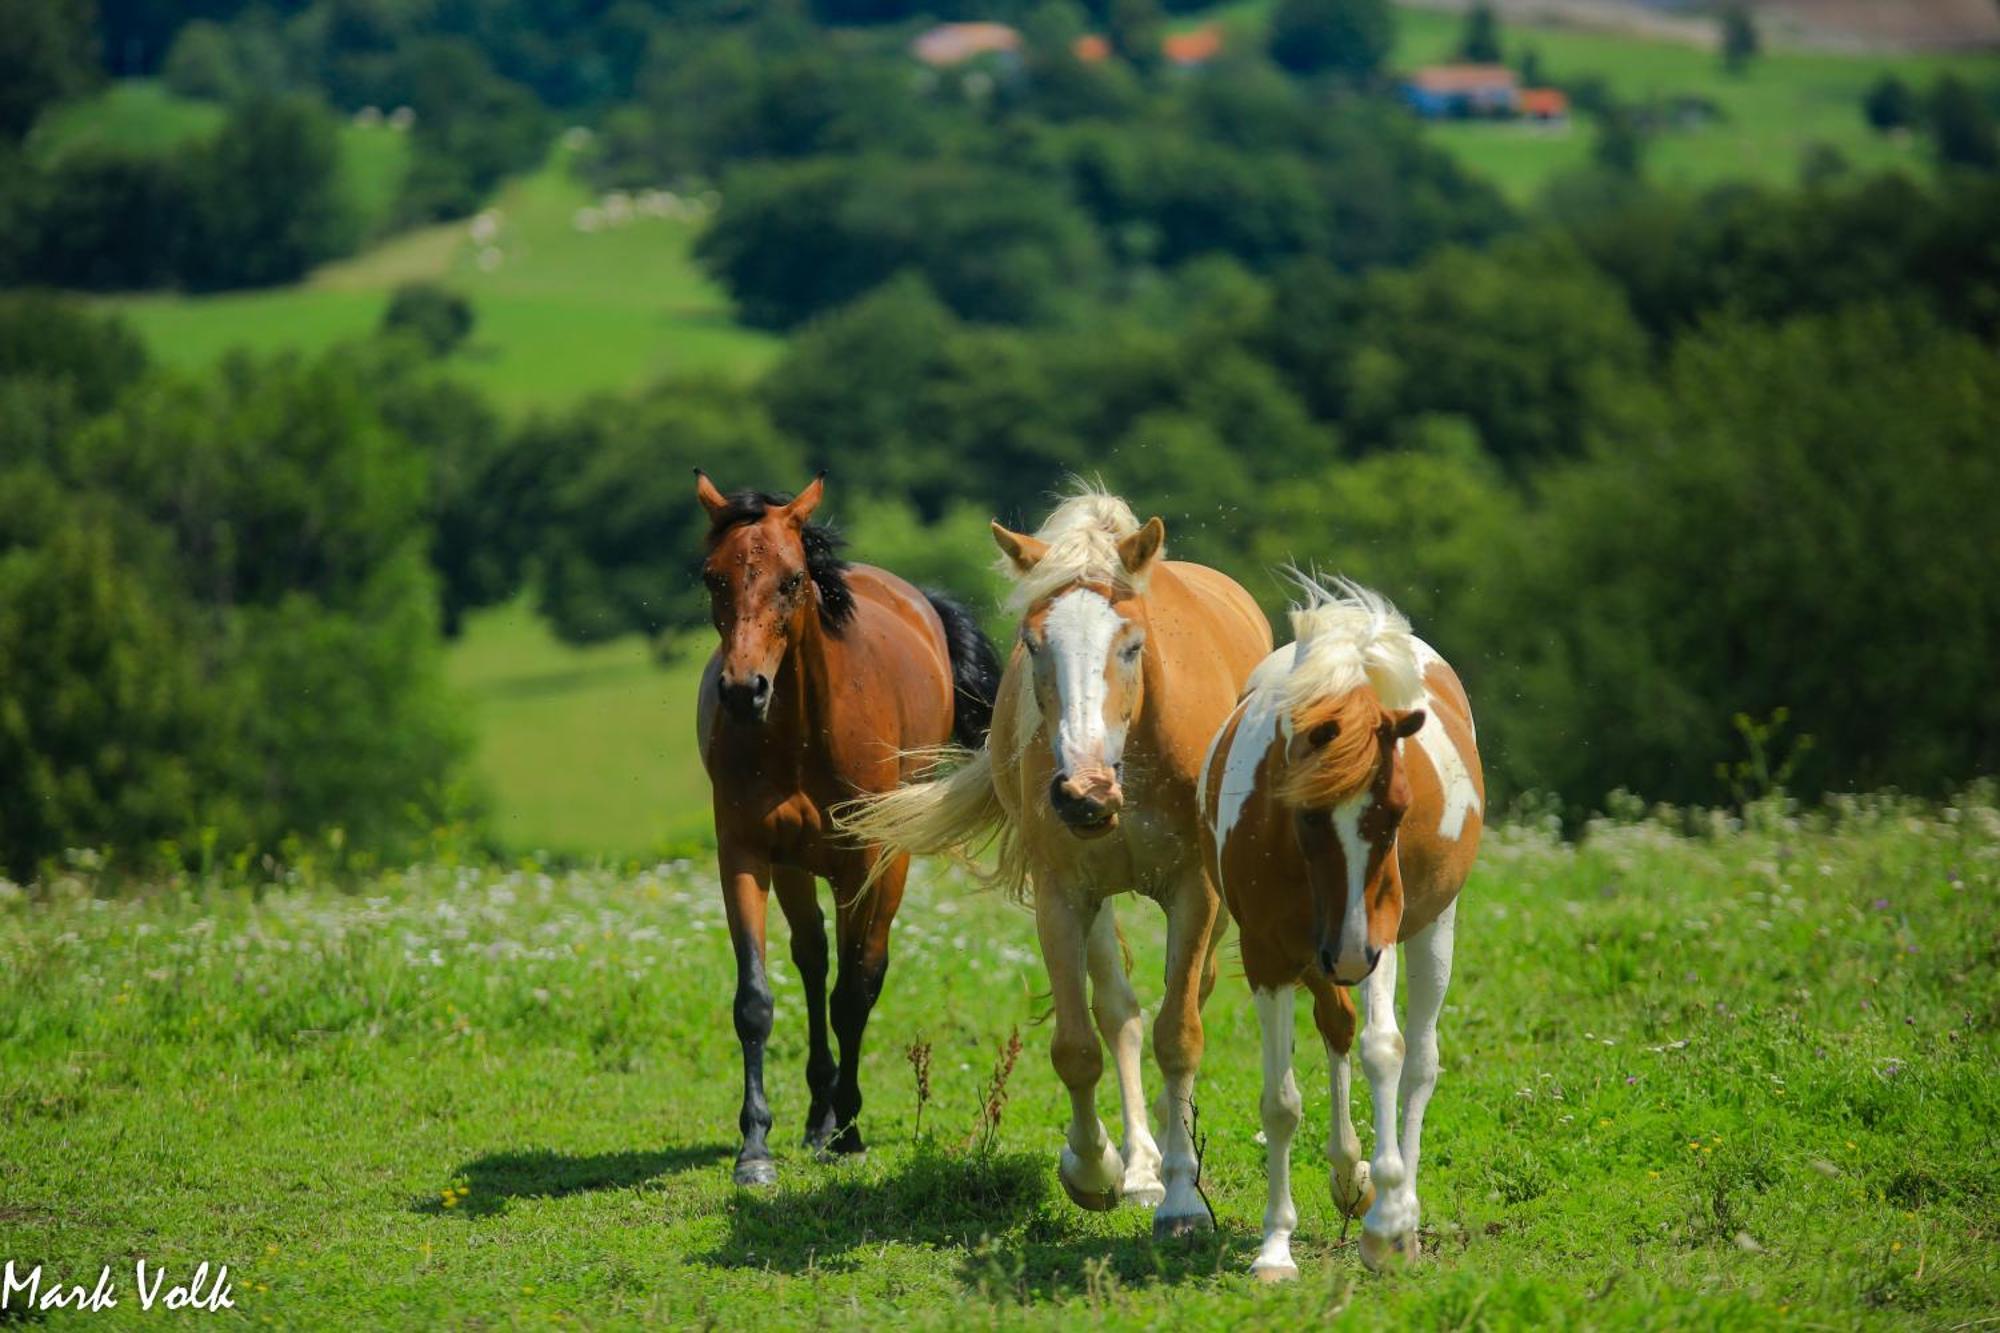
[832,747,1026,897]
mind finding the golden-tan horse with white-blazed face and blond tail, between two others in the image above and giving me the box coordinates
[840,490,1270,1235]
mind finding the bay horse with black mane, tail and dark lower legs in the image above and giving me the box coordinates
[696,472,1000,1185]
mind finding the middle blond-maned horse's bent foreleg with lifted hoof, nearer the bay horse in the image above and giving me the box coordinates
[1034,883,1124,1211]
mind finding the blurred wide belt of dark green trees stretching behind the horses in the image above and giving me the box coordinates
[0,0,2000,875]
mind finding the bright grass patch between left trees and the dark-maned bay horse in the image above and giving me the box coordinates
[446,604,712,859]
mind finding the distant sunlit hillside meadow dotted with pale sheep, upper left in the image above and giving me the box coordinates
[112,142,778,414]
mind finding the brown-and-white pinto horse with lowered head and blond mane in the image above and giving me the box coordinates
[1202,578,1486,1281]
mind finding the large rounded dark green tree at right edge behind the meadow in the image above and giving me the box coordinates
[1474,306,2000,807]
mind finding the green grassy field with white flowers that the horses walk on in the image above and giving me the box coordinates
[0,791,2000,1329]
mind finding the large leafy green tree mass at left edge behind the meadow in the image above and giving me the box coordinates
[0,338,464,873]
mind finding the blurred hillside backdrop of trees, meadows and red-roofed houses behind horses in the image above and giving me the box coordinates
[0,0,2000,879]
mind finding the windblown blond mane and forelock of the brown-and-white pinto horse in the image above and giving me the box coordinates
[1274,568,1424,807]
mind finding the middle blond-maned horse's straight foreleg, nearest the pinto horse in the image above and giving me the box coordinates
[1152,877,1218,1237]
